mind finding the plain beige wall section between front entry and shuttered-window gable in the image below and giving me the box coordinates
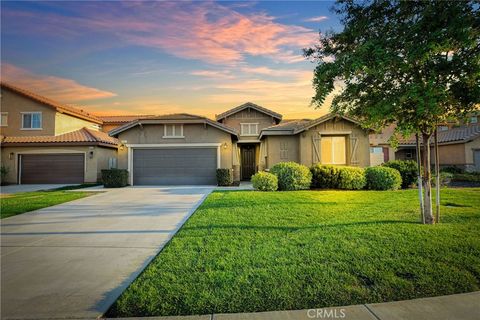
[265,135,300,169]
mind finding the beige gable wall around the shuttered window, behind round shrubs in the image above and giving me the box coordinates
[299,119,370,167]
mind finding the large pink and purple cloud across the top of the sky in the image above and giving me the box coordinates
[4,1,317,64]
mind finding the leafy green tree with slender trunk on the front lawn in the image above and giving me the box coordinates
[304,0,480,224]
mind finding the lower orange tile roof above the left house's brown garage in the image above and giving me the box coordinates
[2,128,119,146]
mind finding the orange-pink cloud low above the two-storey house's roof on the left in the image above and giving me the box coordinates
[1,63,116,103]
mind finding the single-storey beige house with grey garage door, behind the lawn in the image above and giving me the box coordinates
[109,102,370,185]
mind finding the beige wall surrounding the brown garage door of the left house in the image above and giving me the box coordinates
[1,146,116,183]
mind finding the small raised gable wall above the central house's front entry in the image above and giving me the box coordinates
[222,108,275,140]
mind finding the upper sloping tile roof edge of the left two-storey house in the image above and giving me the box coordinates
[0,81,102,124]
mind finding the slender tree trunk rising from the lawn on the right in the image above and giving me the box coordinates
[422,133,434,224]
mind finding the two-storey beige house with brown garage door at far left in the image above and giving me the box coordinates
[0,83,118,184]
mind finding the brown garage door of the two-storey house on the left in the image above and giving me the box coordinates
[20,154,85,184]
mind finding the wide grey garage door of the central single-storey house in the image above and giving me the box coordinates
[133,148,217,185]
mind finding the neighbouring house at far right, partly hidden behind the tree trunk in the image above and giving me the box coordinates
[395,123,480,171]
